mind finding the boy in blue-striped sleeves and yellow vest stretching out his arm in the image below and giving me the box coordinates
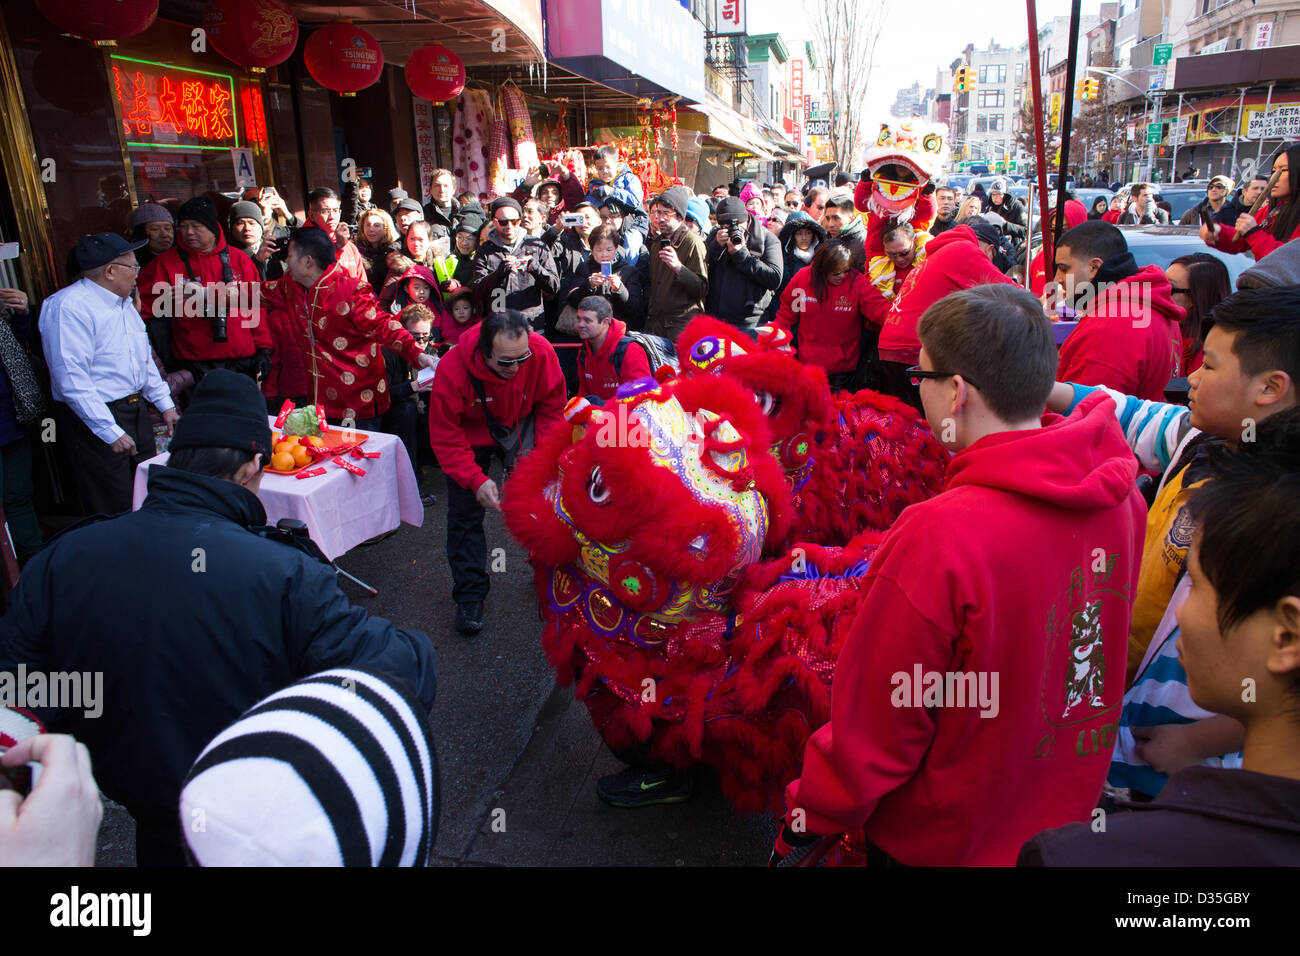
[1048,287,1300,800]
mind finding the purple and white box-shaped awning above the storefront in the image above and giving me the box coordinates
[546,0,705,103]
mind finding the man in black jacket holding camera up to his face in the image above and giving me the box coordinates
[705,196,781,329]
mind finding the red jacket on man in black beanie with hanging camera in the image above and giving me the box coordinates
[137,233,272,362]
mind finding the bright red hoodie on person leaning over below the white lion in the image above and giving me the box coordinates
[880,226,1015,365]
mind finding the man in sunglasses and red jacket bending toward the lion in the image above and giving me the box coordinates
[429,310,564,635]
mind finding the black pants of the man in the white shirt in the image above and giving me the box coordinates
[55,398,156,515]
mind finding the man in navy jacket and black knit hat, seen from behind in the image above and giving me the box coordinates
[0,369,436,866]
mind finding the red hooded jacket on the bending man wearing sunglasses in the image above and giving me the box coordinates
[429,323,566,492]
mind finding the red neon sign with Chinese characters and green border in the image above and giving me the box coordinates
[111,56,240,150]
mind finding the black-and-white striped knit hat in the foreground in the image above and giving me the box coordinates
[179,667,438,866]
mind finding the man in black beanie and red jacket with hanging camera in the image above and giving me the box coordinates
[139,196,270,381]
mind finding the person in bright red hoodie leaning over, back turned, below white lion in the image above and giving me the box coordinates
[880,222,1011,410]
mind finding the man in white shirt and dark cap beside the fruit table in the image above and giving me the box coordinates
[40,233,179,514]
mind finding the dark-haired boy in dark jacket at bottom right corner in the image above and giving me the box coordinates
[1019,411,1300,866]
